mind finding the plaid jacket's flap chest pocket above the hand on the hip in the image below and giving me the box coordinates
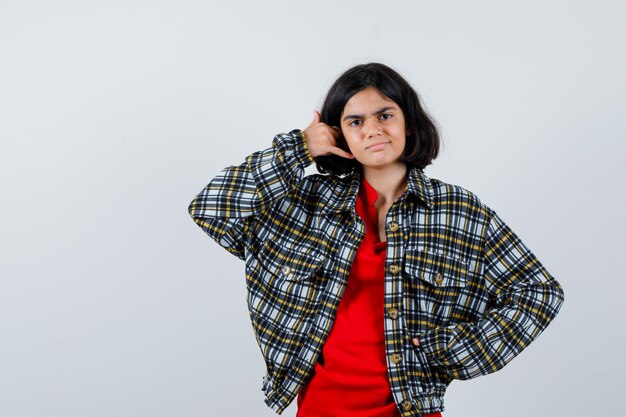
[404,248,469,331]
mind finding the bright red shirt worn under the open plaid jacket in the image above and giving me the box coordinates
[297,179,441,417]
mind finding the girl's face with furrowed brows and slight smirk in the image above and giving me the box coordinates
[341,87,408,169]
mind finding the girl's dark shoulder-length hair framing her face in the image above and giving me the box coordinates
[315,62,441,175]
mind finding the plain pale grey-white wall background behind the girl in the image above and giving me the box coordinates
[0,0,626,417]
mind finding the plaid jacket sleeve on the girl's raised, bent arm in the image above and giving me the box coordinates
[188,133,313,259]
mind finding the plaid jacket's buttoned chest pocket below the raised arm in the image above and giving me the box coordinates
[246,240,324,332]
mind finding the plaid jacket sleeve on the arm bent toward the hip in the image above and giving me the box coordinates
[419,209,564,379]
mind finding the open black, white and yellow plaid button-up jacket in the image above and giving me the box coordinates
[188,133,563,416]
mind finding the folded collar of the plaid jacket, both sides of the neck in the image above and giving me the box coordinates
[322,168,433,214]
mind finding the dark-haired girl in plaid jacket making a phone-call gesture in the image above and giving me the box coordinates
[189,63,563,417]
